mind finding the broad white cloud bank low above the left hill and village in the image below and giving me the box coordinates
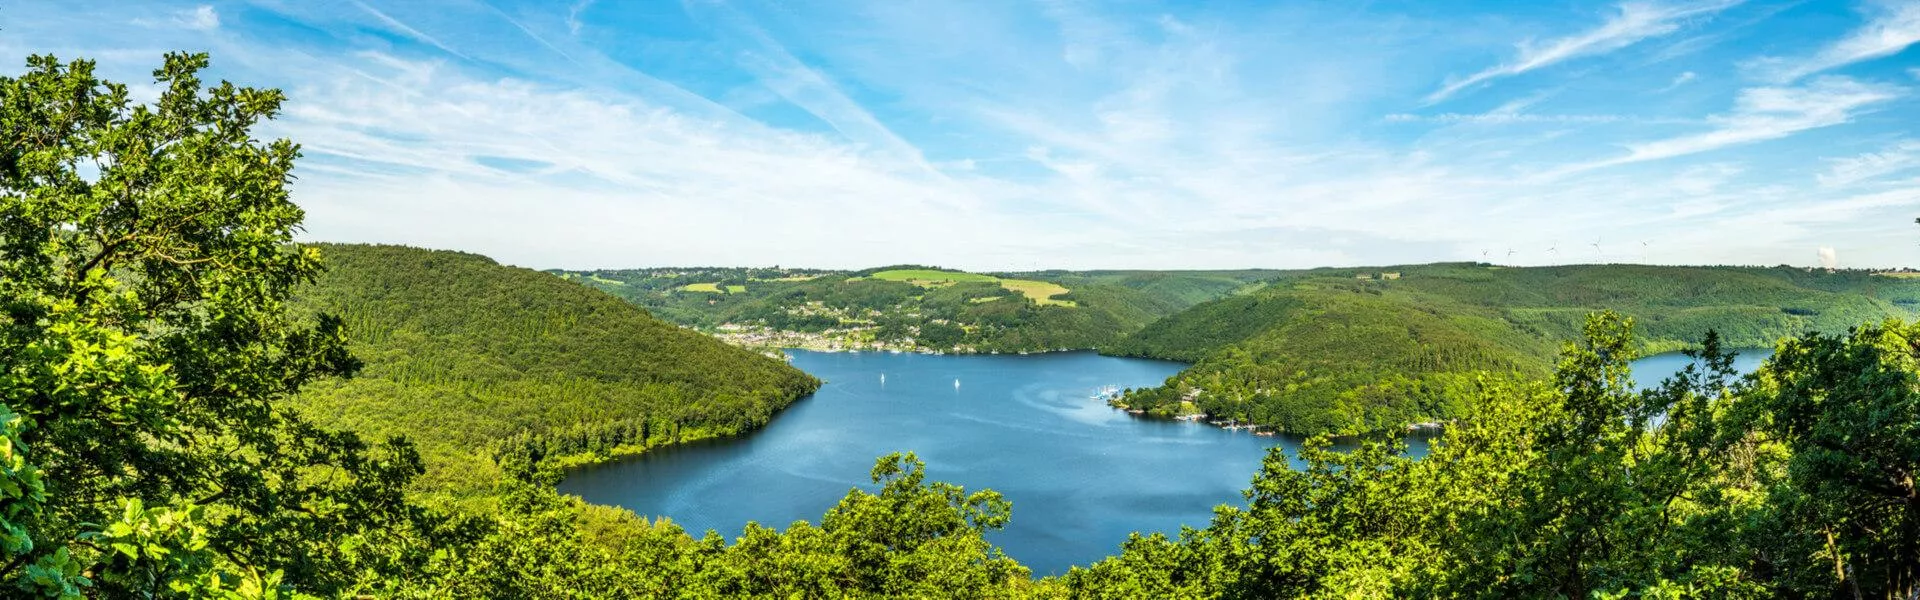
[271,56,1041,265]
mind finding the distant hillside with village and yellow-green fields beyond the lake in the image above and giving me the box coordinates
[553,265,1283,352]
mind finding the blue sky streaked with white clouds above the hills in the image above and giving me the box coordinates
[0,0,1920,271]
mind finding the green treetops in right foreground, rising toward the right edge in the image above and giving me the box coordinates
[1054,313,1920,598]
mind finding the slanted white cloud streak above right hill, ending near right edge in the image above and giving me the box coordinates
[1569,77,1903,171]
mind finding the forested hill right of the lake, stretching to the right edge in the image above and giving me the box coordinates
[1106,263,1920,433]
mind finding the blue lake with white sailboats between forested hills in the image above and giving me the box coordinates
[561,350,1764,575]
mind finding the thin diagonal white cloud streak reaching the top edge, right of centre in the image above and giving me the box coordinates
[1427,0,1741,104]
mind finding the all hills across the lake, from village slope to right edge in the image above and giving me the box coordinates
[553,263,1920,435]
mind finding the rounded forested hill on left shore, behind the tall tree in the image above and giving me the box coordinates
[298,244,818,487]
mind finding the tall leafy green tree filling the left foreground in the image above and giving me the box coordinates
[0,54,420,596]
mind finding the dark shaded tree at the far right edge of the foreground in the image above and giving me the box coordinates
[1749,321,1920,598]
